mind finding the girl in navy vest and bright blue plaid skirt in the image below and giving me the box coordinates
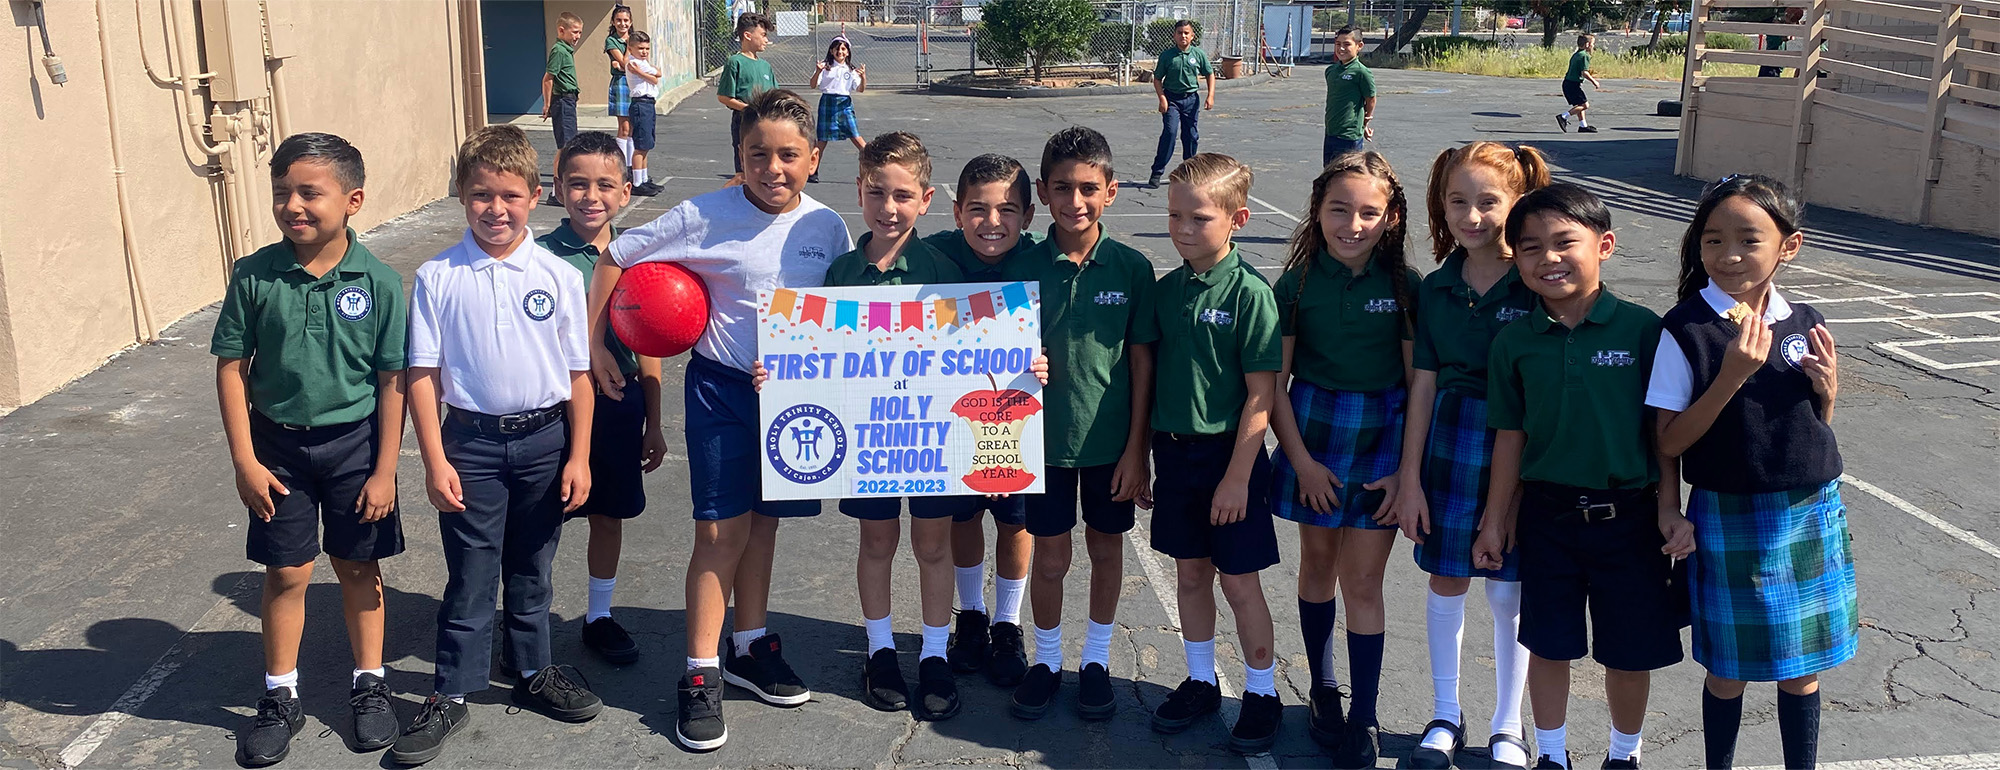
[1646,174,1860,768]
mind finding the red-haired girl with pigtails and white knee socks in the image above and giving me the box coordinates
[1396,142,1548,770]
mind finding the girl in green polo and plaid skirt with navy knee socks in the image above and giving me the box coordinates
[1272,152,1418,768]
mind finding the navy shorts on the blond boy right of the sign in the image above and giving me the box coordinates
[1152,432,1278,574]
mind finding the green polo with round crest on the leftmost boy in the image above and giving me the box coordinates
[208,228,410,428]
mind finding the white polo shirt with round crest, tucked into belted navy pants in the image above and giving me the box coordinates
[410,230,590,414]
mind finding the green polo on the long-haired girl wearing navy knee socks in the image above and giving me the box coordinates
[1272,250,1420,392]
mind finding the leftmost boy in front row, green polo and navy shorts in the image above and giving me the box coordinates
[210,134,408,768]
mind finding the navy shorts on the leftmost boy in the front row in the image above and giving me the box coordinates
[244,412,402,566]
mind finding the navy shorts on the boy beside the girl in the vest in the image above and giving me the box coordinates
[1516,482,1688,672]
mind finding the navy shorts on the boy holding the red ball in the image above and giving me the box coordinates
[684,354,820,522]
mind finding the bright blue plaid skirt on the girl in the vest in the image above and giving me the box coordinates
[1688,480,1860,682]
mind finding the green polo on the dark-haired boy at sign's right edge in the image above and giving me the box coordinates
[1002,226,1158,468]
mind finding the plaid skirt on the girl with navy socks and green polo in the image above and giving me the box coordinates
[1270,378,1406,530]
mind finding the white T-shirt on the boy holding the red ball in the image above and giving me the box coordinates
[616,186,854,372]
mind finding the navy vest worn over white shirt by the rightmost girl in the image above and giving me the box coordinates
[1660,296,1840,494]
